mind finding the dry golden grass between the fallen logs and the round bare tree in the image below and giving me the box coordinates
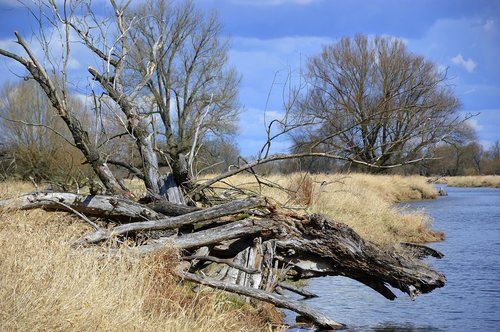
[211,173,443,245]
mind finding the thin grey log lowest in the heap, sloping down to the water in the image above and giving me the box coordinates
[179,272,345,330]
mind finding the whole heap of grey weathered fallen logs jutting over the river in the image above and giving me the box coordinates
[0,193,446,329]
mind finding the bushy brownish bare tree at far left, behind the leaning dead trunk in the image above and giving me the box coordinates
[0,81,91,182]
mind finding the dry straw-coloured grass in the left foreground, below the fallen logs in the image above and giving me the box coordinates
[0,182,282,331]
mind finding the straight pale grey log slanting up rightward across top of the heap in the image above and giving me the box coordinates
[82,197,263,243]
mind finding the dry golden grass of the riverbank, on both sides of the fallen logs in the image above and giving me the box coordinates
[0,174,442,331]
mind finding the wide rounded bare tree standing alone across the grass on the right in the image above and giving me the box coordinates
[296,35,463,171]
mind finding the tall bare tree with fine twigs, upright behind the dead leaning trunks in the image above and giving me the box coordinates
[127,0,239,191]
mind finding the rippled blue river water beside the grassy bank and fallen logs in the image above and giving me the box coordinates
[288,187,500,332]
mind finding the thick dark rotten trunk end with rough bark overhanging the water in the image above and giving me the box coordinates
[276,215,446,300]
